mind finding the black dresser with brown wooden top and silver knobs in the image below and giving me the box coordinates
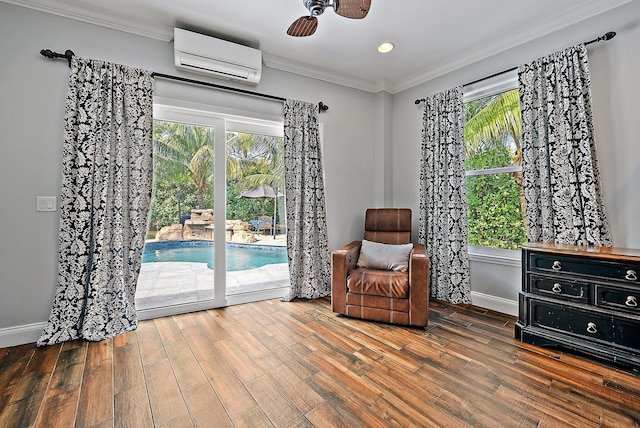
[515,243,640,372]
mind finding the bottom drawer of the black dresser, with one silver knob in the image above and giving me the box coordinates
[530,300,615,343]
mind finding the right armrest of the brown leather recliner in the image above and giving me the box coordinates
[409,244,429,327]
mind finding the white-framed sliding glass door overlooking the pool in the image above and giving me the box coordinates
[136,105,289,318]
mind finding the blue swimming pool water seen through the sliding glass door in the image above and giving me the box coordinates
[142,241,287,271]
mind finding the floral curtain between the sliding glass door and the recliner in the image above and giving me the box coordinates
[283,100,331,301]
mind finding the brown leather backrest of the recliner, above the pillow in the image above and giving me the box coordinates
[364,208,411,244]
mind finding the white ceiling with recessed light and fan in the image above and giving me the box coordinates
[0,0,631,93]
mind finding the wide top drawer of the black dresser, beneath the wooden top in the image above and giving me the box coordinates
[529,252,640,284]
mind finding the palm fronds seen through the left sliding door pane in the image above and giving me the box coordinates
[153,121,213,209]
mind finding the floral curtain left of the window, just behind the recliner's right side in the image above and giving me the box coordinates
[419,87,471,303]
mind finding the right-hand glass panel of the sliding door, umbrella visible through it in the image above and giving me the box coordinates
[226,129,289,302]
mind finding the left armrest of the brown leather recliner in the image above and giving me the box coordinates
[331,241,362,315]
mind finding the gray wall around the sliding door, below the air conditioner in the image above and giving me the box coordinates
[0,3,384,338]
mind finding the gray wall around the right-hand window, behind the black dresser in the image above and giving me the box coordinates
[392,1,640,307]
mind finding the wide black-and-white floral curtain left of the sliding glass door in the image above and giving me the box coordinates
[38,57,153,345]
